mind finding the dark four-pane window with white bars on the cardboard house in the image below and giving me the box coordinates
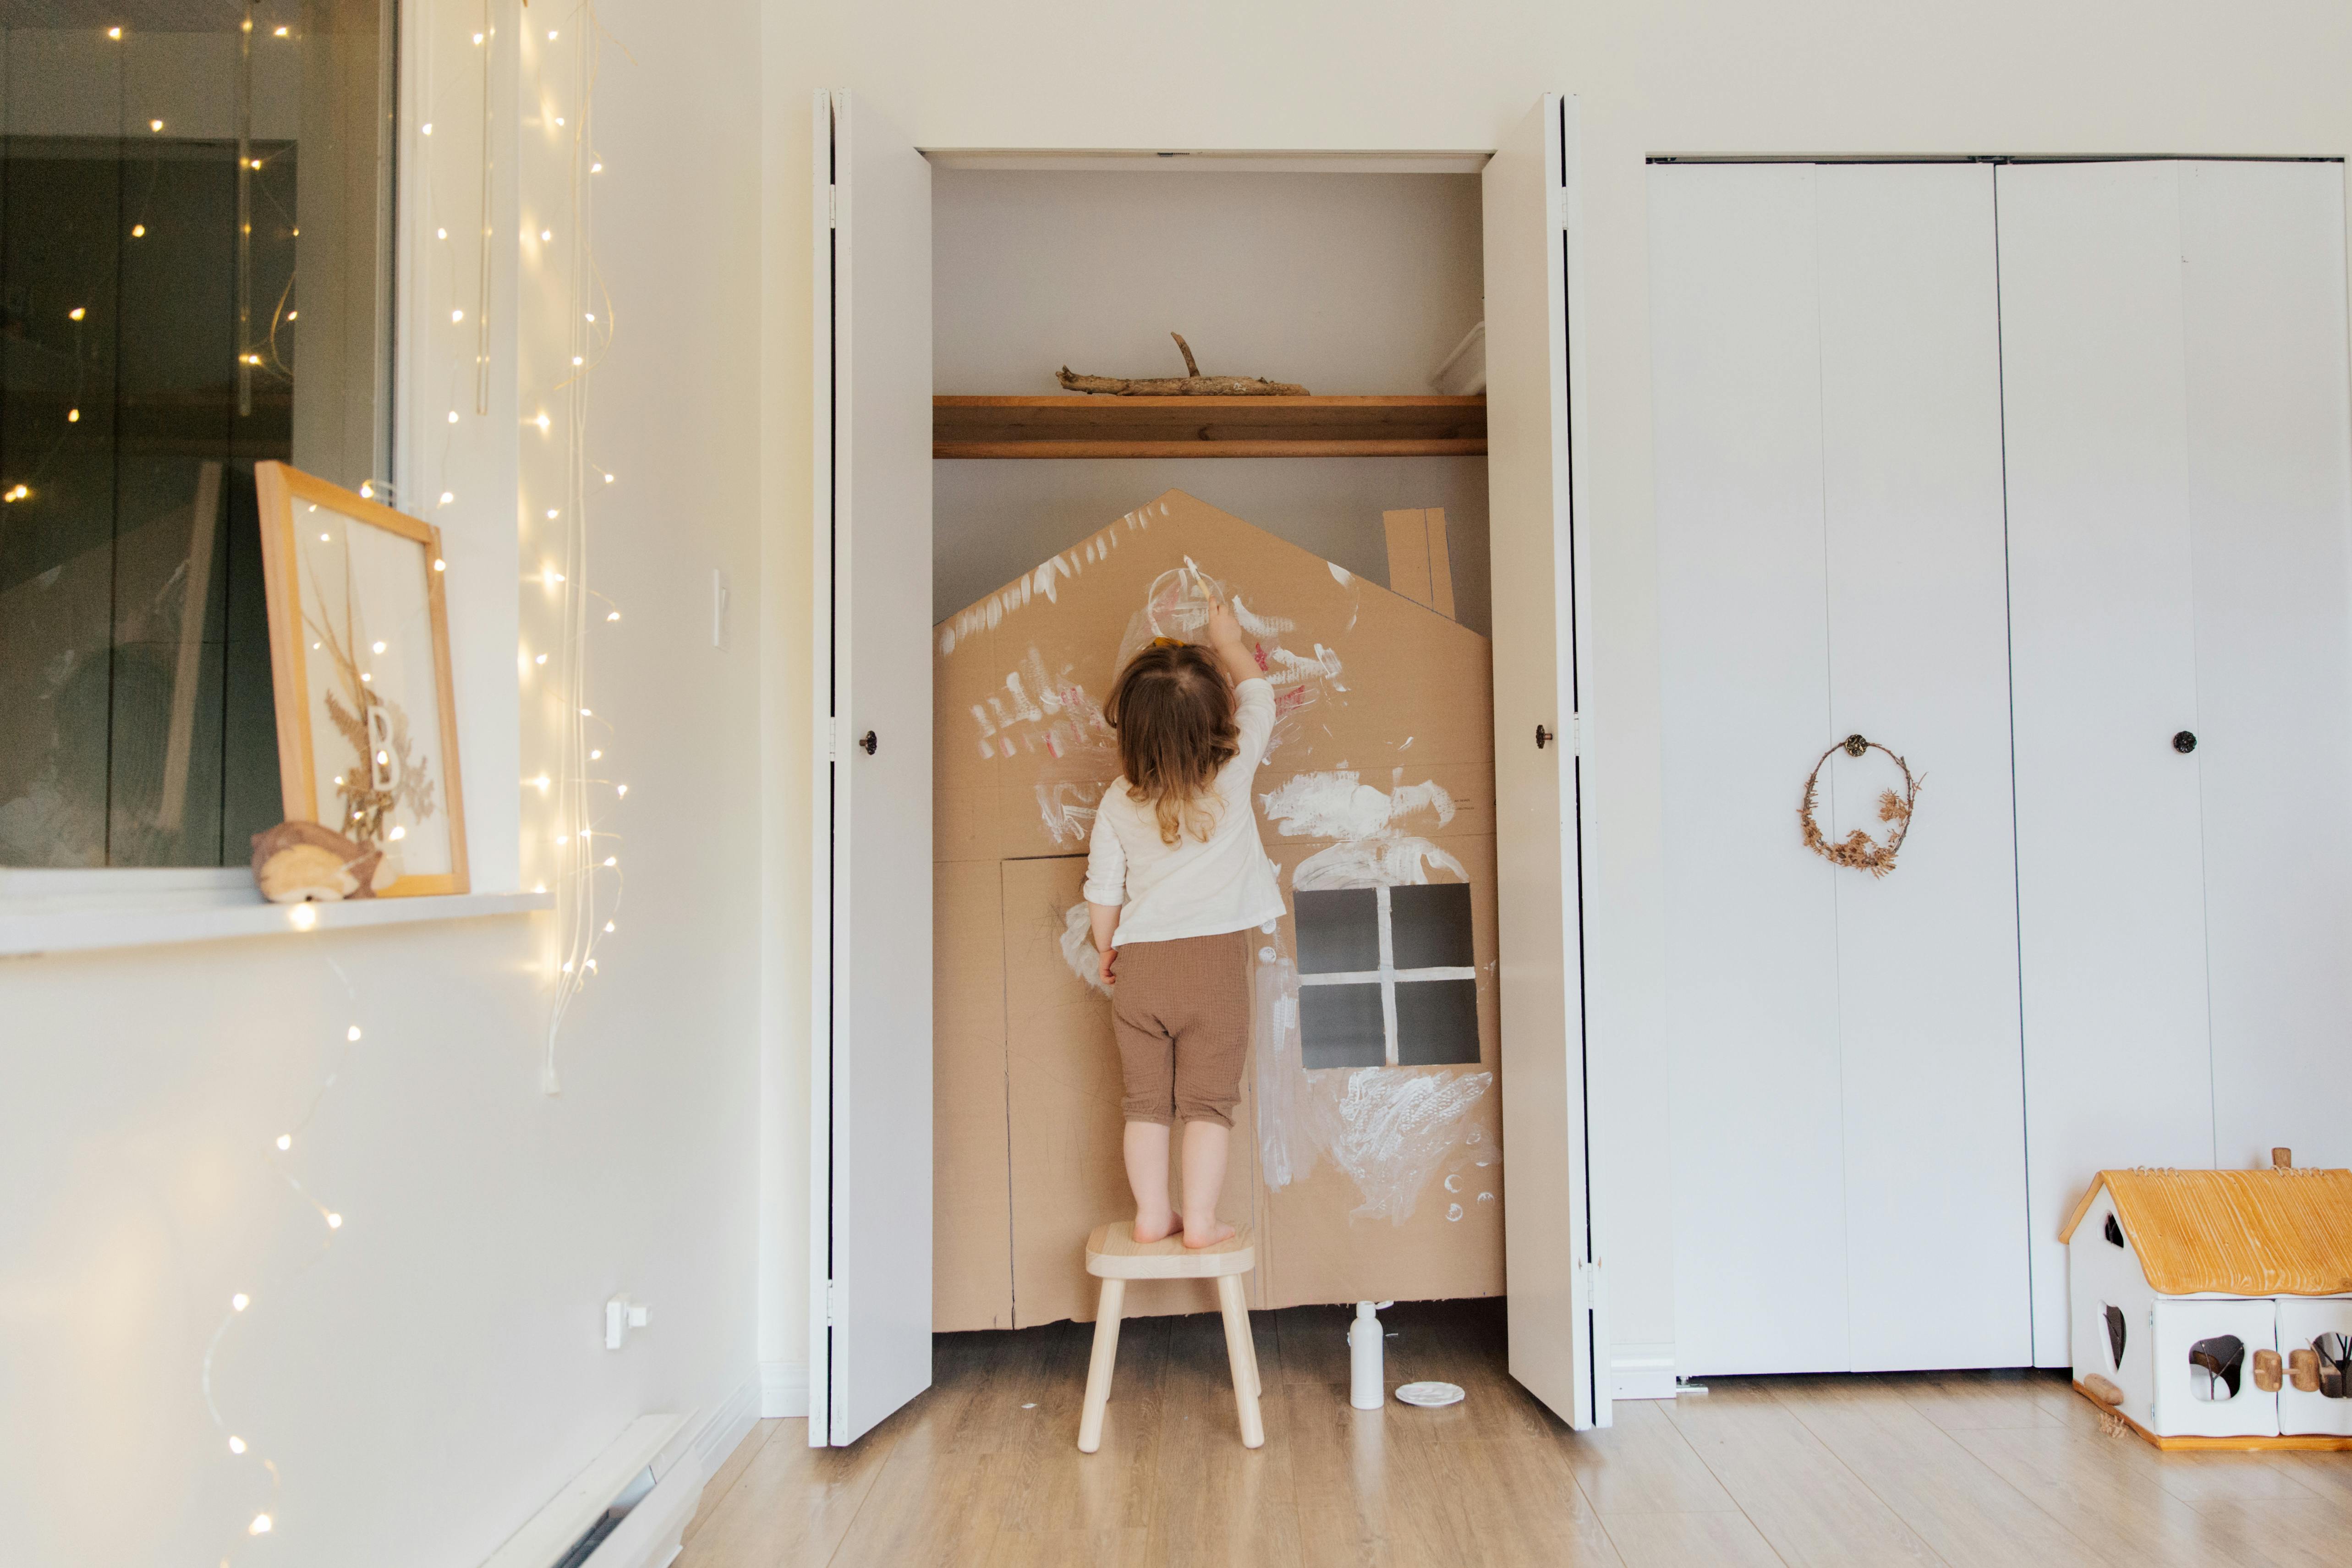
[1296,882,1477,1067]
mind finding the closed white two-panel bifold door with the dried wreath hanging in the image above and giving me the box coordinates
[1649,164,2030,1373]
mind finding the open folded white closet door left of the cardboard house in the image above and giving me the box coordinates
[809,92,932,1446]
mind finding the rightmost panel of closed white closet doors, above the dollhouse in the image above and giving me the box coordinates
[2180,162,2352,1184]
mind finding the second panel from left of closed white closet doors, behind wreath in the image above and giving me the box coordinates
[1806,164,2032,1371]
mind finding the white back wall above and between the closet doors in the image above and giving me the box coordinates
[762,0,2352,1382]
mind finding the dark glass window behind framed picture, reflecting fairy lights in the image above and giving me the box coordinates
[0,0,393,867]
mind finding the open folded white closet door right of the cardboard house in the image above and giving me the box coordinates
[1482,94,1611,1429]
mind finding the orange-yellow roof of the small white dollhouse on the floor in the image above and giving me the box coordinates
[2058,1168,2352,1295]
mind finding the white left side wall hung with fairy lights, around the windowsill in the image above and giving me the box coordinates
[0,0,762,1568]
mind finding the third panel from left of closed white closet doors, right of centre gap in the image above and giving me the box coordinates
[1997,162,2213,1366]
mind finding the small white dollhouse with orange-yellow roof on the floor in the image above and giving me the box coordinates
[2058,1150,2352,1448]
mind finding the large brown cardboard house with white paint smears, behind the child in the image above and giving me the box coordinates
[932,491,1503,1331]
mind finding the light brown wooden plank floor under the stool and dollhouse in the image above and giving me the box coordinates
[677,1302,2352,1568]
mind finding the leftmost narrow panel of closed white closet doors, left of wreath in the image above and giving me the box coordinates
[1649,164,1846,1373]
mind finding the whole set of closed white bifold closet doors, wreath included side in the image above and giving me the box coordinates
[1649,160,2352,1373]
